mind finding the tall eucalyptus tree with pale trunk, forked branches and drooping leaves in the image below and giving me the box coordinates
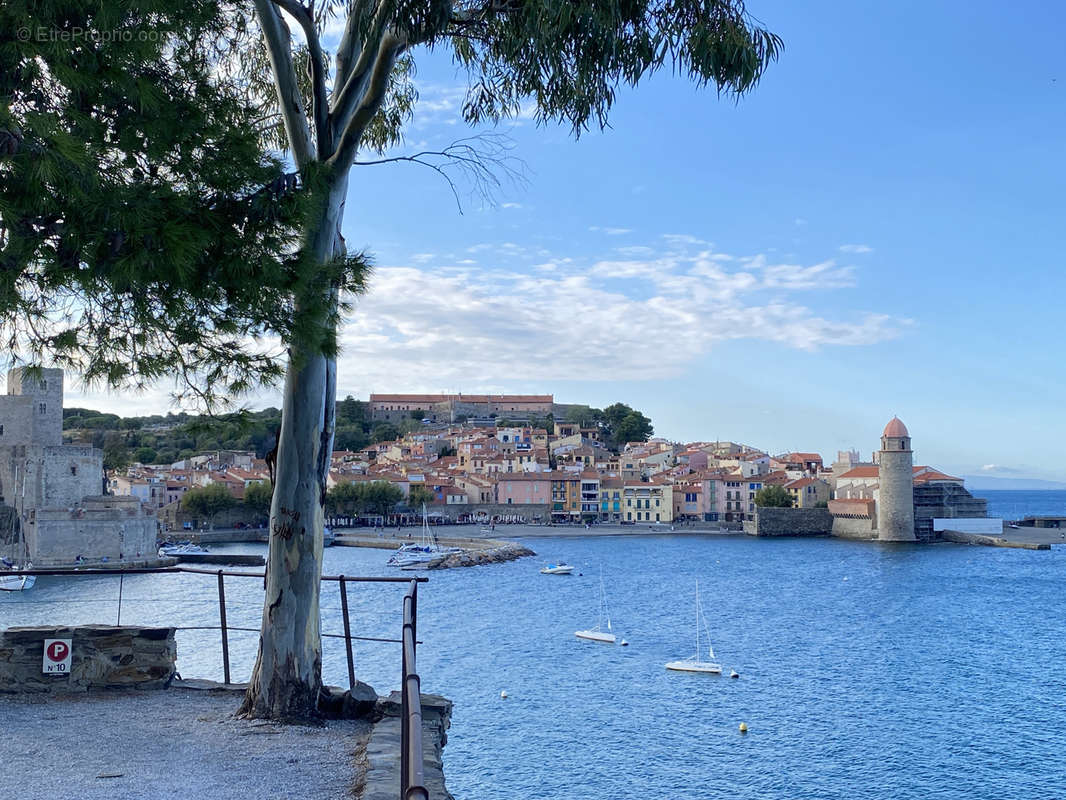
[233,0,781,718]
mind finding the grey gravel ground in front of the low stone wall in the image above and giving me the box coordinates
[0,688,371,800]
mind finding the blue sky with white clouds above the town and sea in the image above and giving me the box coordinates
[67,0,1066,480]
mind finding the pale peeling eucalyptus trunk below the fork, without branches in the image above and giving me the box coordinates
[239,176,348,721]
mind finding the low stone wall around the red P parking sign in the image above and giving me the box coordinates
[0,625,178,692]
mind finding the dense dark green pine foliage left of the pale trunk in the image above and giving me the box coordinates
[0,0,366,404]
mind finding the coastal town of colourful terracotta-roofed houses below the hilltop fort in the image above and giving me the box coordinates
[101,394,985,539]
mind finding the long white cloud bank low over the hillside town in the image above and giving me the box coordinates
[339,237,908,390]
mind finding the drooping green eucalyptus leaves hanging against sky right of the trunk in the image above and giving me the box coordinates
[445,0,782,133]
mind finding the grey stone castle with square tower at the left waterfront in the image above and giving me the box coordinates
[0,368,159,566]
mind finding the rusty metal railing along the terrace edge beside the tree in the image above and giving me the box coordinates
[6,566,430,800]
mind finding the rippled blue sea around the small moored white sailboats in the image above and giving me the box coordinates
[0,492,1066,800]
